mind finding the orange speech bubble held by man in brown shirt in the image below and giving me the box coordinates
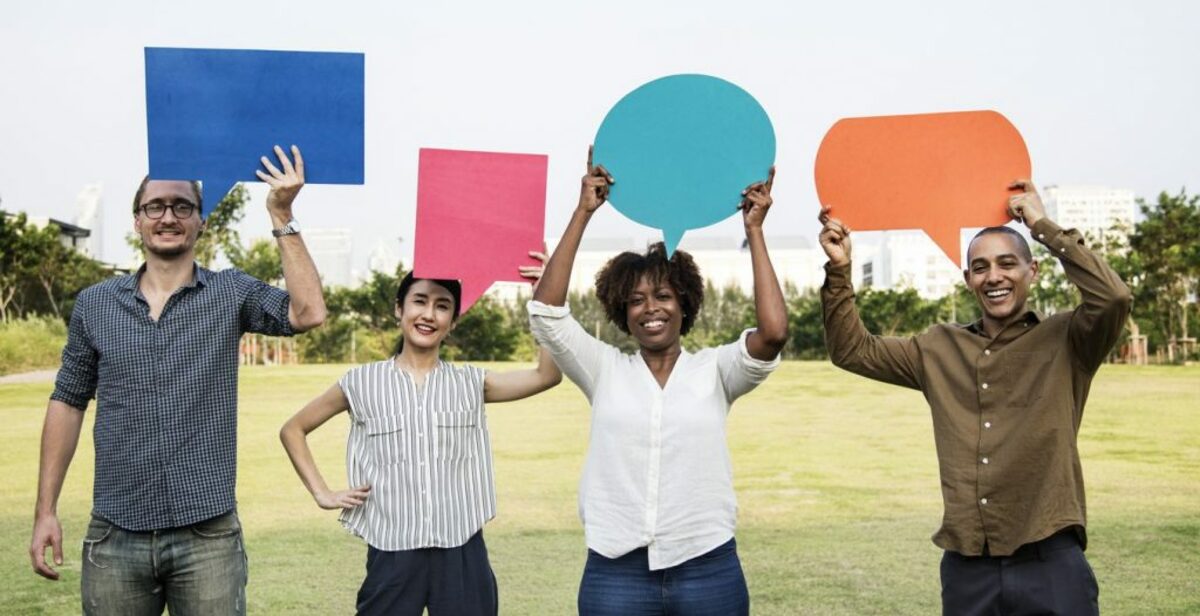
[815,112,1030,263]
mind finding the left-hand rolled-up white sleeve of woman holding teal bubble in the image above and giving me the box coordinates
[527,300,620,401]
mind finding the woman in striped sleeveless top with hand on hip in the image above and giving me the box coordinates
[280,264,562,616]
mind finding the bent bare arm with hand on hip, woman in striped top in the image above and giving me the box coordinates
[280,384,371,509]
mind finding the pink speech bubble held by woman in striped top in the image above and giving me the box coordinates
[413,148,548,312]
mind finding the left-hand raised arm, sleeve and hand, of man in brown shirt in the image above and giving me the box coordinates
[818,205,923,389]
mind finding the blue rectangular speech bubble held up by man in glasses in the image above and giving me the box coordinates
[145,47,364,216]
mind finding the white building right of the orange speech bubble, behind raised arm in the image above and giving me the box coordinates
[1042,185,1138,240]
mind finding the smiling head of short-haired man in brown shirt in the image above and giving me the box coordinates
[962,233,1038,335]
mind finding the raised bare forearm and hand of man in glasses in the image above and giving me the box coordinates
[256,145,326,333]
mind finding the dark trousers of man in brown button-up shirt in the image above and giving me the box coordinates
[942,528,1100,616]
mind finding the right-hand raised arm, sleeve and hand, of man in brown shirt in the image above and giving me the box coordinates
[1008,179,1133,371]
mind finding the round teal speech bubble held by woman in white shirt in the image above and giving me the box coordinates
[593,74,775,256]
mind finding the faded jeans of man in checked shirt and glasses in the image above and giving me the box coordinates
[82,512,246,616]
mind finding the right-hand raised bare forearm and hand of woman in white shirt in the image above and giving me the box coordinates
[742,166,787,360]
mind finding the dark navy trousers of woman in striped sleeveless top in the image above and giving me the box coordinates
[358,531,499,616]
